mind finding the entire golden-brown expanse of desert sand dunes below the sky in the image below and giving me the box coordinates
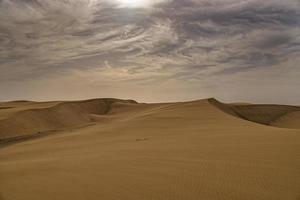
[0,99,300,200]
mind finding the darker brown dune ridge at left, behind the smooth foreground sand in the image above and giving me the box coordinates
[0,98,137,141]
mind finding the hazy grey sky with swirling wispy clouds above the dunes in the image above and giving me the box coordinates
[0,0,300,105]
